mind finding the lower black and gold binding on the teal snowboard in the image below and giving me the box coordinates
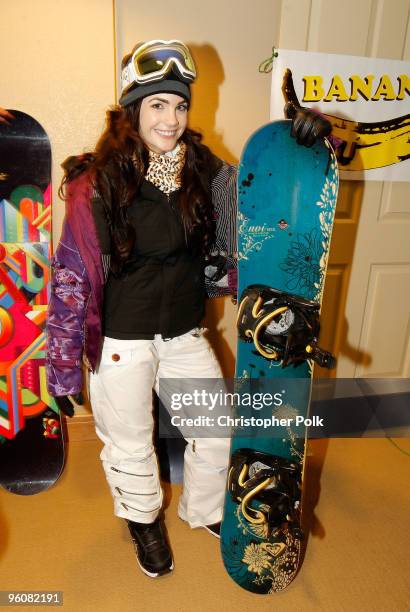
[228,448,303,540]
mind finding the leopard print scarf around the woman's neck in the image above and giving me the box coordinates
[145,142,186,195]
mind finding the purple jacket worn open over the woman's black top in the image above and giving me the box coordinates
[46,163,237,396]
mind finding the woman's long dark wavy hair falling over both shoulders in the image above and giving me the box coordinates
[59,99,216,273]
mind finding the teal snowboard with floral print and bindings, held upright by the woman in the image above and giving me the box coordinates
[221,120,338,593]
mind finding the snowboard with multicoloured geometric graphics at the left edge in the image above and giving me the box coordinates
[0,110,64,495]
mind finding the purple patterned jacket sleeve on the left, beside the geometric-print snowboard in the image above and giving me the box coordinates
[46,219,91,396]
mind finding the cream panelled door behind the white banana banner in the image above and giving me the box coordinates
[278,0,410,378]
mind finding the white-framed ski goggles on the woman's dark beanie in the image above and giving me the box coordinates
[121,40,196,93]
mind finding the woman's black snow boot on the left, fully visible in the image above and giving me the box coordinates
[127,518,174,578]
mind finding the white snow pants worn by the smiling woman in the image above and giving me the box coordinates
[90,330,230,527]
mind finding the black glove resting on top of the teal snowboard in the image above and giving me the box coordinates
[284,102,332,147]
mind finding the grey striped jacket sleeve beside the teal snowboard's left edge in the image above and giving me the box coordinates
[205,162,237,297]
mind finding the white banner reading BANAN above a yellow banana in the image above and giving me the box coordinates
[270,49,410,181]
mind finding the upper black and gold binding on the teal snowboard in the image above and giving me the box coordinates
[237,285,336,369]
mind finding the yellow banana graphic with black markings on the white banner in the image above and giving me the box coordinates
[282,69,410,170]
